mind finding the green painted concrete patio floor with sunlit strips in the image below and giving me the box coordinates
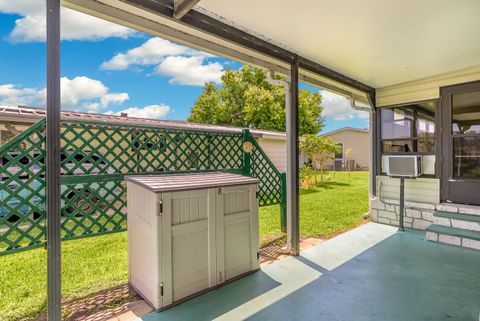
[138,223,480,321]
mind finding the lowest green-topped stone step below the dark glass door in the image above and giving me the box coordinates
[426,224,480,250]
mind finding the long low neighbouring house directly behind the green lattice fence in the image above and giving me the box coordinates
[0,106,303,172]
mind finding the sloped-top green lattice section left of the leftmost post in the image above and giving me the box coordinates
[0,121,45,254]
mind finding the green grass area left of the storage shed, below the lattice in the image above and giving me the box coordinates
[0,232,127,321]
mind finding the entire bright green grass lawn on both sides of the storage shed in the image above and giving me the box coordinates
[0,172,368,321]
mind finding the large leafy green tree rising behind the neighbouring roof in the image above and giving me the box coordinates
[188,66,324,135]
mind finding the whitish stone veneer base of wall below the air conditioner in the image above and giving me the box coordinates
[370,197,440,230]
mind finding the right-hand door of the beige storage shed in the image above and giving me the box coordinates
[217,185,258,283]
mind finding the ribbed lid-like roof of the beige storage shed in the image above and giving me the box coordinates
[125,172,259,193]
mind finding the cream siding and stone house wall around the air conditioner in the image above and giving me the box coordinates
[370,65,480,230]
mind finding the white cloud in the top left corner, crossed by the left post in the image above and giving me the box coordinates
[0,0,135,42]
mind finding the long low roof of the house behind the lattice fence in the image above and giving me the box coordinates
[0,106,286,138]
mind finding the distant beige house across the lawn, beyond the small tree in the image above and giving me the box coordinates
[320,127,370,170]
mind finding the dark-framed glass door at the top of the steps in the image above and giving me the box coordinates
[441,82,480,204]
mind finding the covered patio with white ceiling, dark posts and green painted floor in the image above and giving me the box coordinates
[34,0,480,321]
